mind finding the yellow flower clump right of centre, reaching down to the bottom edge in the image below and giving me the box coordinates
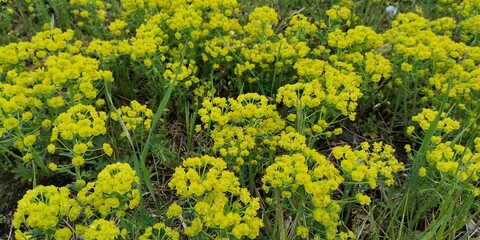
[262,132,343,239]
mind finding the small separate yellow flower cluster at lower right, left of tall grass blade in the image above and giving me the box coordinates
[332,142,404,189]
